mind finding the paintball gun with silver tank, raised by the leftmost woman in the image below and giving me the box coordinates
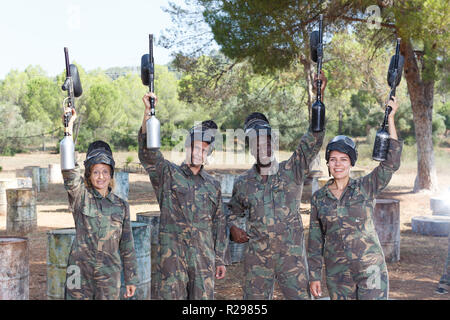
[59,48,83,170]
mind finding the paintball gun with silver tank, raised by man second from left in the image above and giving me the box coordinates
[141,34,161,149]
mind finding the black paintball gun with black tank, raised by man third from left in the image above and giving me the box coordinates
[309,14,325,132]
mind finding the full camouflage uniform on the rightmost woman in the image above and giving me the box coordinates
[308,139,403,300]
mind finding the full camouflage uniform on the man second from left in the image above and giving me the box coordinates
[139,127,227,300]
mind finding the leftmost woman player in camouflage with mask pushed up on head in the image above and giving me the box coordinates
[62,108,139,300]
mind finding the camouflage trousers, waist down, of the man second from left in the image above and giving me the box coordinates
[154,238,215,300]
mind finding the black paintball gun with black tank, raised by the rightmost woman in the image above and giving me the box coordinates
[372,38,405,161]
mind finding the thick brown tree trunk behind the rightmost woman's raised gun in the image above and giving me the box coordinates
[401,39,437,192]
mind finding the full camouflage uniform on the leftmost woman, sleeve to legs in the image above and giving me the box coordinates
[62,164,139,300]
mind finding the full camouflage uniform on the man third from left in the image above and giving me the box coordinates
[229,130,325,300]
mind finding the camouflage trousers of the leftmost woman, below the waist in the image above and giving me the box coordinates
[64,263,121,300]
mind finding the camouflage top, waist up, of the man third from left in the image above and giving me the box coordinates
[228,130,325,244]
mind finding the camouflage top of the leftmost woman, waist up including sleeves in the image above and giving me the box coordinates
[62,164,139,285]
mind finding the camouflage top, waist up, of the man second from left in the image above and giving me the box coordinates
[139,131,227,266]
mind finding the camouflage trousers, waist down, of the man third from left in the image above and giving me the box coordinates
[243,239,310,300]
